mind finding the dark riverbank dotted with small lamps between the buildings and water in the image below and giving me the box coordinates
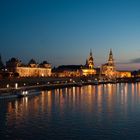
[0,77,140,96]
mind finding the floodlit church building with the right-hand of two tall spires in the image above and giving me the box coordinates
[101,49,116,79]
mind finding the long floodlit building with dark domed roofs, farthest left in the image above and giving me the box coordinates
[6,58,51,77]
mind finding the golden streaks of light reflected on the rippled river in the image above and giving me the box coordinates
[6,83,140,126]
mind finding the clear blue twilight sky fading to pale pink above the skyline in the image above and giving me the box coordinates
[0,0,140,70]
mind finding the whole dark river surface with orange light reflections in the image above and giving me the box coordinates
[0,83,140,140]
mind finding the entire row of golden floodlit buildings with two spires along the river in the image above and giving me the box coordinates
[3,49,131,80]
